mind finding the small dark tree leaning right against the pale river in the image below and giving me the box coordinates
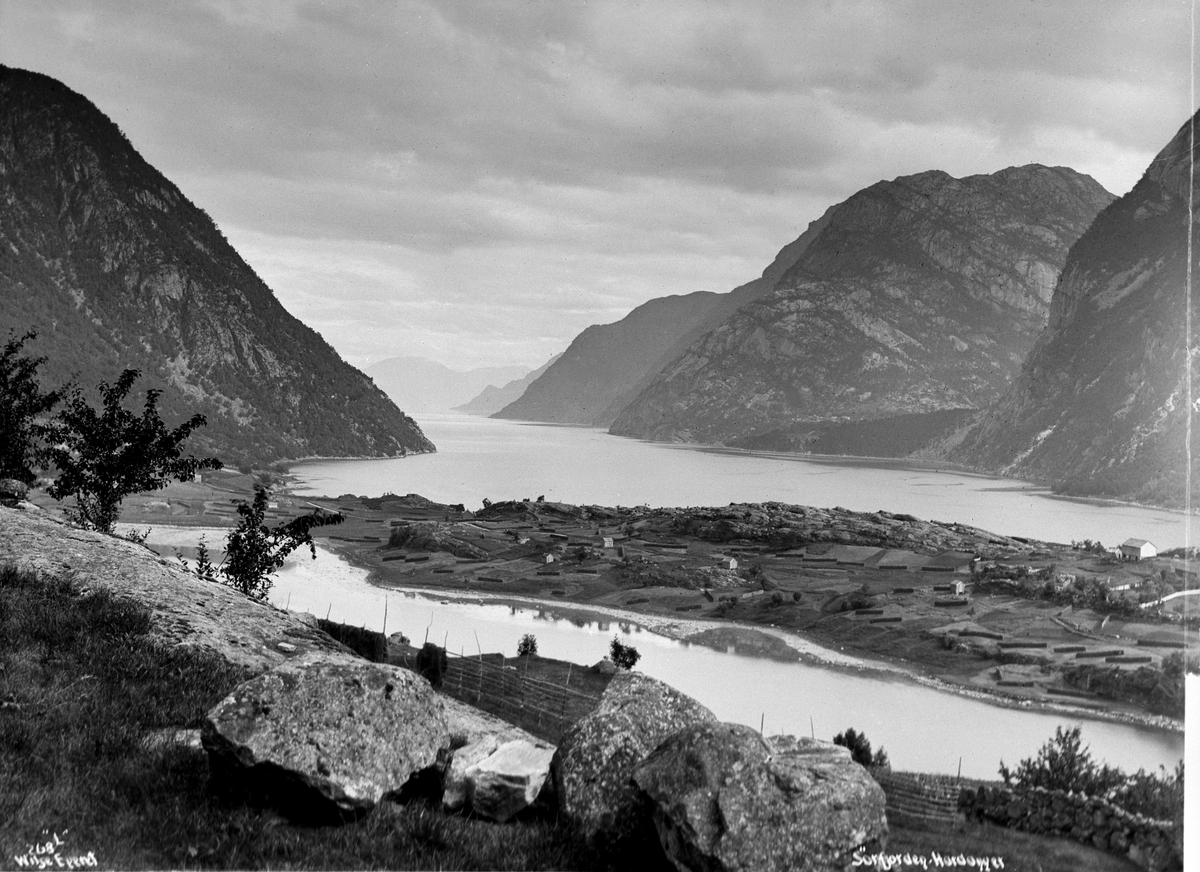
[212,485,344,600]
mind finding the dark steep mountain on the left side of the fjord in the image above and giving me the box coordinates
[0,66,433,463]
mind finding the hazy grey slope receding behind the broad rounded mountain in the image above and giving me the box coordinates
[493,210,833,427]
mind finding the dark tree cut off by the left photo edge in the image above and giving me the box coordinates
[0,331,64,485]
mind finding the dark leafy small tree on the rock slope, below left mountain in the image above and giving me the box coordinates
[46,369,221,533]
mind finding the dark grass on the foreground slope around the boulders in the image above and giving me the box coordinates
[0,566,1134,872]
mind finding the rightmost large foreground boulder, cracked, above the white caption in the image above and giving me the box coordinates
[634,723,887,872]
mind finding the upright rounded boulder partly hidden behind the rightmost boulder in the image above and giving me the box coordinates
[552,670,716,842]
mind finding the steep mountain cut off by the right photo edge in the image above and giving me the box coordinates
[950,110,1200,505]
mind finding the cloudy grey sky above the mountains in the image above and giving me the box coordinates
[0,0,1192,368]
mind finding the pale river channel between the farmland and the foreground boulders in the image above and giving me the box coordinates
[271,549,1183,778]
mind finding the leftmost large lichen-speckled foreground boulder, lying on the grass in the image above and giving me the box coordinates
[202,654,449,822]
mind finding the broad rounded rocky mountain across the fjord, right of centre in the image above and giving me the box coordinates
[611,166,1112,453]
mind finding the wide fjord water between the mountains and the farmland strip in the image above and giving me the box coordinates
[292,414,1200,549]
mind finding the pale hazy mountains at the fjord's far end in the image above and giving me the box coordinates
[365,357,529,411]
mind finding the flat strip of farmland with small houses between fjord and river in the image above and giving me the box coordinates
[96,471,1196,726]
